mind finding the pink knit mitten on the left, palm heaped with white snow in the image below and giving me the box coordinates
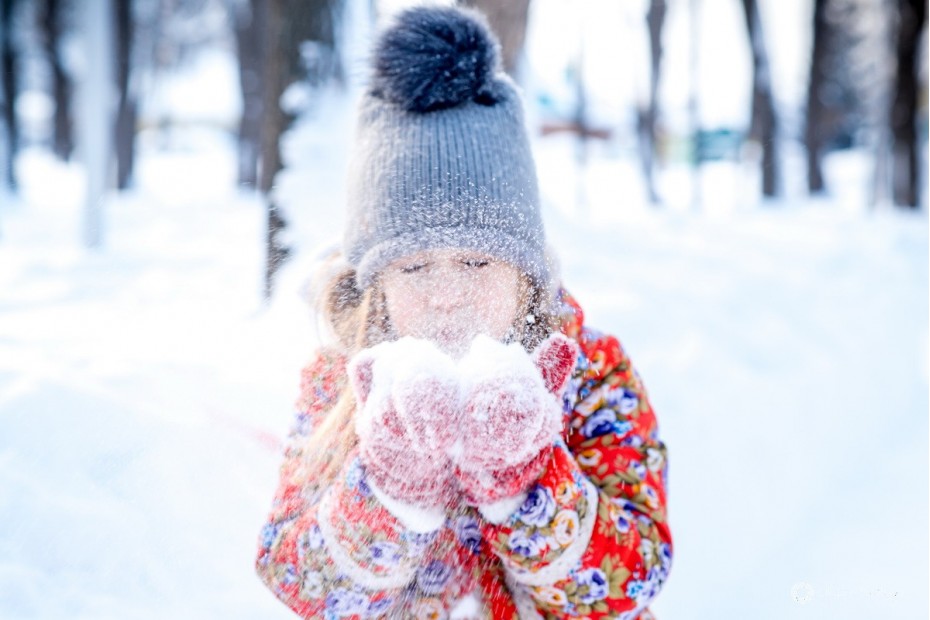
[348,338,459,521]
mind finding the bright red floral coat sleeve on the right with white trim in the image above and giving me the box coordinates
[483,329,672,619]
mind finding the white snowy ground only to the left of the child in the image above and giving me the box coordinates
[0,143,308,619]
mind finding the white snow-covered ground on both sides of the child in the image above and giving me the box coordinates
[0,2,930,620]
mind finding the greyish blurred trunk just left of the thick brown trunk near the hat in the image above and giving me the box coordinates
[236,0,266,187]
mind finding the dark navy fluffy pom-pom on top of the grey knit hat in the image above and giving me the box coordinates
[372,6,499,112]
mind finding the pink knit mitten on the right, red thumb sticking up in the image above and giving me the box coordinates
[453,334,576,520]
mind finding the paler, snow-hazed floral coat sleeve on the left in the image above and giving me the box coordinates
[256,352,432,618]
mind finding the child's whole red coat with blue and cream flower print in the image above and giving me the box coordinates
[256,291,672,620]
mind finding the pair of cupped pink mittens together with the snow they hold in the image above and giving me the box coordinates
[349,334,576,530]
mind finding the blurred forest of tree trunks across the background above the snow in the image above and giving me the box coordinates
[0,0,928,296]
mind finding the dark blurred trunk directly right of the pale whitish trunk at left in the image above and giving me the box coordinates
[113,0,137,189]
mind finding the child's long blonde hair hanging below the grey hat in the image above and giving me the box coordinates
[303,254,558,486]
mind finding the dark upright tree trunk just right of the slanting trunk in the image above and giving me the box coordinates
[804,0,830,194]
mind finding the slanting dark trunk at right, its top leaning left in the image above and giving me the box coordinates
[743,0,781,198]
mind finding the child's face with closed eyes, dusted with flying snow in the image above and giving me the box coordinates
[381,249,525,356]
